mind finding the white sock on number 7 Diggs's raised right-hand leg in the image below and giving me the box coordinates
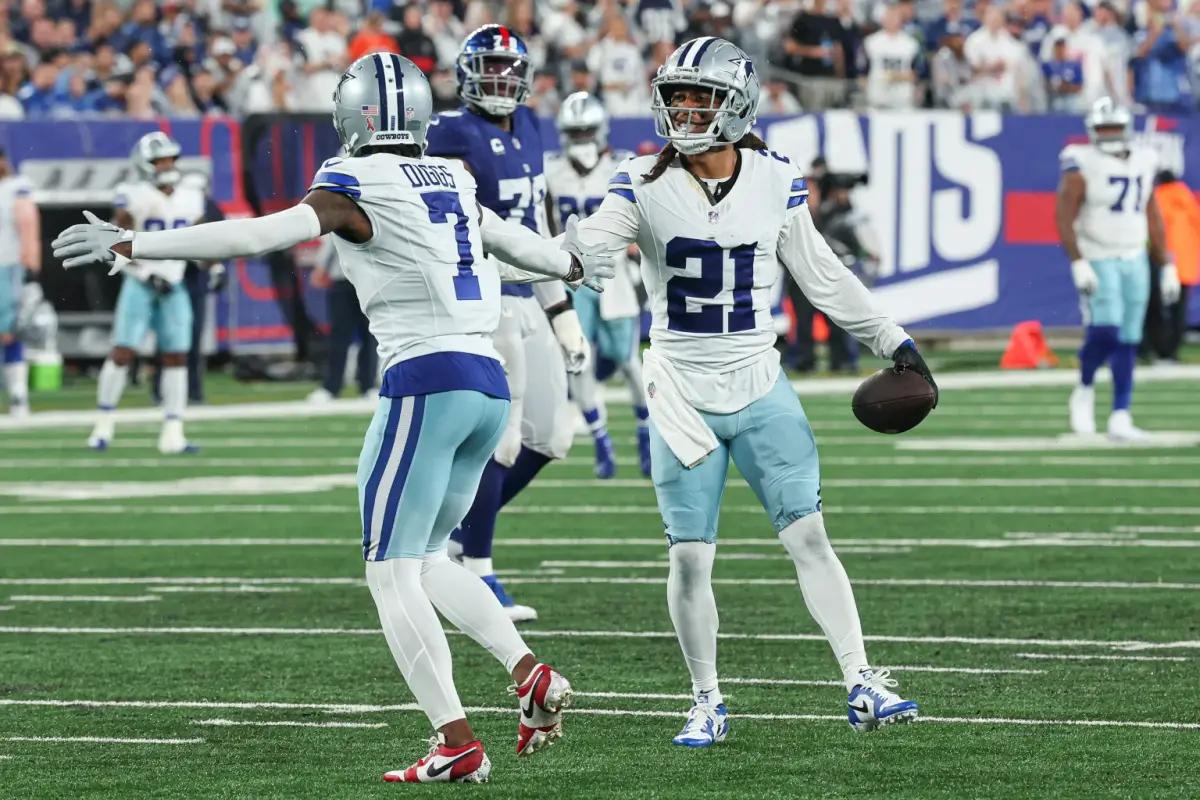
[421,553,532,673]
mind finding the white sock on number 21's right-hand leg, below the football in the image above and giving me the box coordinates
[779,511,866,691]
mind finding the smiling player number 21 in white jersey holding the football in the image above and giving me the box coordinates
[566,37,936,747]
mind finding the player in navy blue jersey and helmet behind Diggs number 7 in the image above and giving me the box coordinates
[428,25,588,621]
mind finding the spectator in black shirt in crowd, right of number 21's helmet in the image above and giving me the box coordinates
[784,0,846,112]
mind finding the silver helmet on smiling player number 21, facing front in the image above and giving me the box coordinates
[650,36,761,156]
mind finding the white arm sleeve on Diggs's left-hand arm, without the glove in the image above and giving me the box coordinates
[133,203,320,261]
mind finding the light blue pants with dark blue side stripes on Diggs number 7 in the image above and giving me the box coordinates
[359,391,509,561]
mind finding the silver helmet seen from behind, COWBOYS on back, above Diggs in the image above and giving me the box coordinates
[334,53,433,156]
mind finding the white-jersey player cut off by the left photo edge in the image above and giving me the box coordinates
[0,150,42,420]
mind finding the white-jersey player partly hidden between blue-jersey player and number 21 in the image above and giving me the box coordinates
[546,91,650,479]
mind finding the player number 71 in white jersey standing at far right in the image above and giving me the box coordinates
[1055,97,1180,441]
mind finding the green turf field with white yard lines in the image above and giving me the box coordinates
[0,378,1200,799]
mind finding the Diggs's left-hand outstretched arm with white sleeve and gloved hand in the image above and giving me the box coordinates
[52,190,360,272]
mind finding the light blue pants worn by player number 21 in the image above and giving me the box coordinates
[650,372,821,543]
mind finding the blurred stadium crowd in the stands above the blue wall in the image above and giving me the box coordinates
[0,0,1200,119]
